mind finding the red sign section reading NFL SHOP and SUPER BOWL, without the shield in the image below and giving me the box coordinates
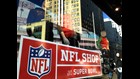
[57,45,102,79]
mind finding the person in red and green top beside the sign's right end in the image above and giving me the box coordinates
[97,30,109,78]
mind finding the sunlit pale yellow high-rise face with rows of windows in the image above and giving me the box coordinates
[46,0,82,33]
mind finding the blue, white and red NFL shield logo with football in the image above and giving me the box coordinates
[27,45,52,78]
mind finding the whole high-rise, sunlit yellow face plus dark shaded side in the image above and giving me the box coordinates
[44,0,104,35]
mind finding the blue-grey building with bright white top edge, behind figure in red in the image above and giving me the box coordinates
[104,18,122,56]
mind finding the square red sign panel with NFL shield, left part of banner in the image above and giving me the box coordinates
[17,36,56,79]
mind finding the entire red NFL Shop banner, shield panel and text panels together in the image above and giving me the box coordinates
[17,36,102,79]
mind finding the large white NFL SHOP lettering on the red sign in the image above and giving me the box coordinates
[61,50,99,63]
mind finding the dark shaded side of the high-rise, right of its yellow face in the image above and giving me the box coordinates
[81,0,104,36]
